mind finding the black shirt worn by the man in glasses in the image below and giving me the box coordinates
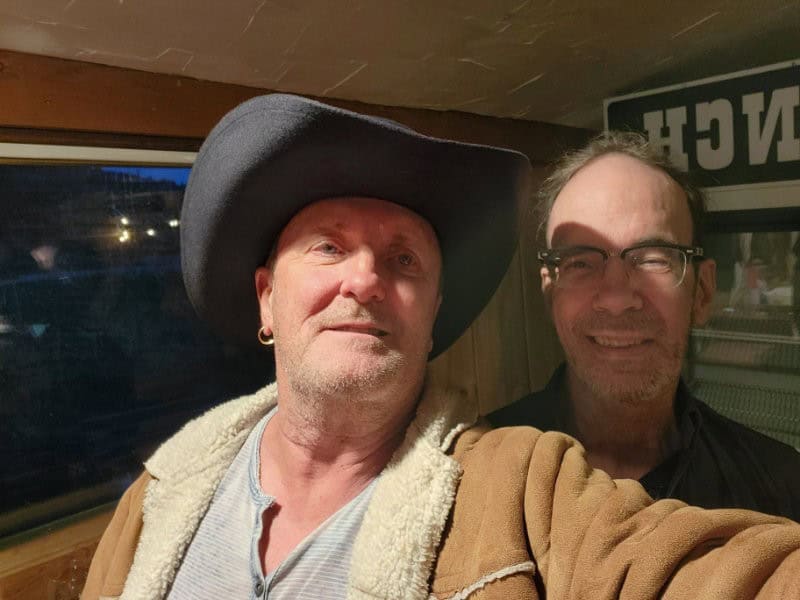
[487,365,800,521]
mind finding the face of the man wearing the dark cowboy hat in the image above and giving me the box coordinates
[256,198,441,404]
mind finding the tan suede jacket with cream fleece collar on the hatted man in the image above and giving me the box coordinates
[82,385,800,600]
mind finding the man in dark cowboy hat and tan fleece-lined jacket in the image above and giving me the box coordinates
[83,94,800,599]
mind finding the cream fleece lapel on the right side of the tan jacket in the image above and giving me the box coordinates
[347,390,478,600]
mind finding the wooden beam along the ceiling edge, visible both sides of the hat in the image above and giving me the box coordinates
[0,50,592,163]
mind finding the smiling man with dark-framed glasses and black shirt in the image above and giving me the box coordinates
[489,133,800,520]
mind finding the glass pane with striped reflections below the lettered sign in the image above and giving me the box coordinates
[690,229,800,449]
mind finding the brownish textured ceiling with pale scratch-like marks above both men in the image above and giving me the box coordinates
[0,0,800,129]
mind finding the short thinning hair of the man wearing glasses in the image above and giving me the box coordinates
[537,131,706,246]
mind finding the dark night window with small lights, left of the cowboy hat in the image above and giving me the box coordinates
[0,164,274,538]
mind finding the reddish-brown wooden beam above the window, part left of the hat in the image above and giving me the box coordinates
[0,51,256,138]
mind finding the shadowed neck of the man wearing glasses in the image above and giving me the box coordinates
[563,367,680,479]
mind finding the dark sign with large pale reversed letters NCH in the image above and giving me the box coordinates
[605,61,800,187]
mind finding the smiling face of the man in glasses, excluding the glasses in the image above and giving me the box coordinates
[541,153,715,402]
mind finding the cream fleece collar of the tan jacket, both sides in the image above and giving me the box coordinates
[121,384,478,600]
